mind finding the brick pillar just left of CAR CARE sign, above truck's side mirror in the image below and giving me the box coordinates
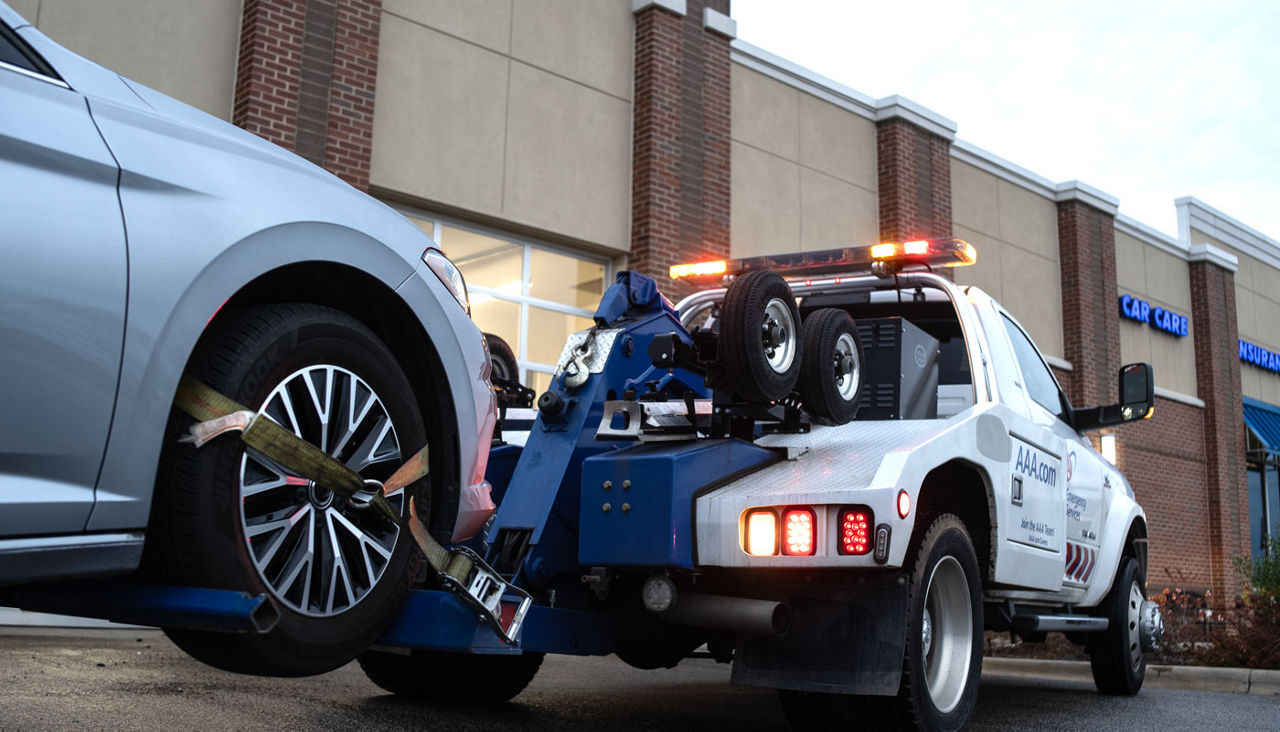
[1057,195,1120,407]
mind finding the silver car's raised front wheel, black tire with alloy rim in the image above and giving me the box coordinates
[143,305,430,676]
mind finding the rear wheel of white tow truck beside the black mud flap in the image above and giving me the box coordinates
[846,514,983,729]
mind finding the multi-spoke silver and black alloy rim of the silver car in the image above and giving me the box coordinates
[239,365,404,617]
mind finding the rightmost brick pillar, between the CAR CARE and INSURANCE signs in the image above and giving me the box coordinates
[1188,253,1249,604]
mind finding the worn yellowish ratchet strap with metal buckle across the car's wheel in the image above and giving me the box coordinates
[174,376,532,645]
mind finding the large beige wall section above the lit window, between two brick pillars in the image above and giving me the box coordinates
[370,0,635,252]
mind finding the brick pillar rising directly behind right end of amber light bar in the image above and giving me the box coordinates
[876,116,951,242]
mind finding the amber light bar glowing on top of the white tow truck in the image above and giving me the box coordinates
[669,237,978,279]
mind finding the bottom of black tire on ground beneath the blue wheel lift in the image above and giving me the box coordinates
[360,650,543,704]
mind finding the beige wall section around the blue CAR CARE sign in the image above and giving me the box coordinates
[1115,230,1198,397]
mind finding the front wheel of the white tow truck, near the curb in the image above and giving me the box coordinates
[1089,557,1147,696]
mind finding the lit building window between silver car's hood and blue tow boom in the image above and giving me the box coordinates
[406,214,609,394]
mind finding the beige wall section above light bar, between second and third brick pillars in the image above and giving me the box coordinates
[731,64,879,257]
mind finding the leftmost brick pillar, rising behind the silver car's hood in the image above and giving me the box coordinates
[232,0,381,191]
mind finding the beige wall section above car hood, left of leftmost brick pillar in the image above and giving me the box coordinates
[19,0,242,119]
